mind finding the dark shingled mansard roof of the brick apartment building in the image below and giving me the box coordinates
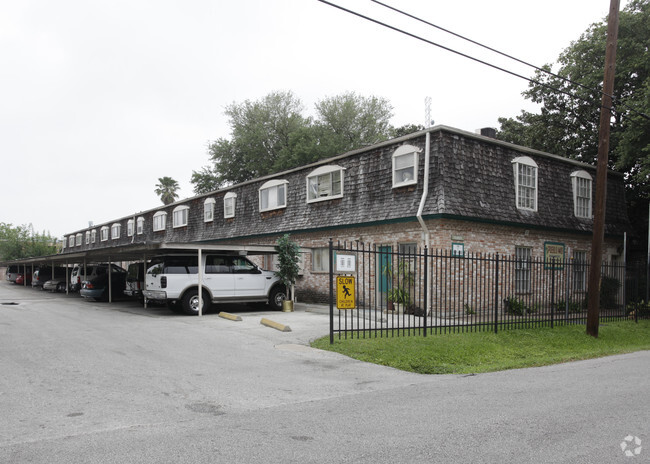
[60,126,628,251]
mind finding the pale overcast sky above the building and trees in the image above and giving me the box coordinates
[0,0,625,237]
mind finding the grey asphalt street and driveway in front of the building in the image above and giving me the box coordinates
[0,282,650,464]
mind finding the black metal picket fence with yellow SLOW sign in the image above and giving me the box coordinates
[330,242,650,341]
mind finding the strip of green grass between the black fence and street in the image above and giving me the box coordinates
[312,320,650,374]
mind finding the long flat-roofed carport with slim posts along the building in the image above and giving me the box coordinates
[2,242,276,316]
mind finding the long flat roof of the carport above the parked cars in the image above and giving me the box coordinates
[2,242,286,265]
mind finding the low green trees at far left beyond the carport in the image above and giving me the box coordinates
[0,222,56,261]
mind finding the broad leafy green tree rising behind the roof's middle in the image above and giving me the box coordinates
[191,92,392,194]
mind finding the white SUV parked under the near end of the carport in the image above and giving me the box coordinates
[143,253,286,314]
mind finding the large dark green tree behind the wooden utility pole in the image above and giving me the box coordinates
[497,0,650,196]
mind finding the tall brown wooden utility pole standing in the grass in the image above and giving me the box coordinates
[587,0,619,337]
